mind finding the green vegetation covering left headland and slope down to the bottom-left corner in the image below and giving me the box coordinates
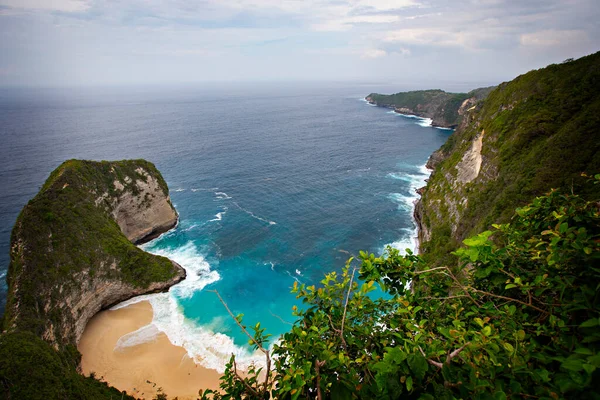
[0,160,177,399]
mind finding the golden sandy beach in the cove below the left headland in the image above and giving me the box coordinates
[78,301,220,400]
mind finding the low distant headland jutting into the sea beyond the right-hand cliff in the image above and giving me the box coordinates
[366,87,494,128]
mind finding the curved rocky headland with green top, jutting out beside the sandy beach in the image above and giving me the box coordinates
[4,160,185,349]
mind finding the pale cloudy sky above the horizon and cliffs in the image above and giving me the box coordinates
[0,0,600,87]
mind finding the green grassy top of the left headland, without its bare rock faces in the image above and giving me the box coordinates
[4,160,176,335]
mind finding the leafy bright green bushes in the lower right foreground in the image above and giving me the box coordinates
[202,179,600,400]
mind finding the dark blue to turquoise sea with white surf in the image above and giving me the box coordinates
[0,84,451,369]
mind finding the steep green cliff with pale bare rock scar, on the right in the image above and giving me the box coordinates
[415,53,600,262]
